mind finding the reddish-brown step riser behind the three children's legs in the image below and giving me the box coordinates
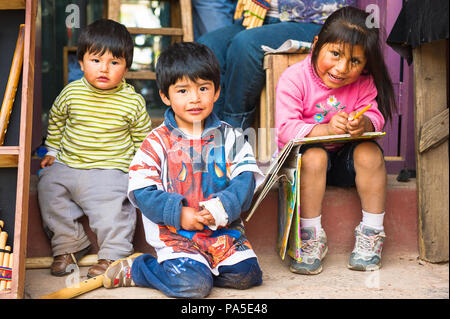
[27,175,418,257]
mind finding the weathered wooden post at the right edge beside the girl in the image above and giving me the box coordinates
[413,40,449,262]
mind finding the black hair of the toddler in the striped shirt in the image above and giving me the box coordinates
[77,19,134,68]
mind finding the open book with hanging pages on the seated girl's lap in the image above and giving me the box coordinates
[245,132,386,261]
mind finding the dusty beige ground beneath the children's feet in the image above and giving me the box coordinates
[25,251,449,299]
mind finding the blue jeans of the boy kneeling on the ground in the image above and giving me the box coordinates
[131,254,262,298]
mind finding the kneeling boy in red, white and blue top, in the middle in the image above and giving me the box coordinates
[104,42,263,298]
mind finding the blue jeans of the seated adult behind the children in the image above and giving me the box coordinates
[197,17,321,130]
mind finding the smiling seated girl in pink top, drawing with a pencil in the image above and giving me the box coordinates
[276,7,396,274]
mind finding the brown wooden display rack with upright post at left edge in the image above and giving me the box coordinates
[0,0,38,299]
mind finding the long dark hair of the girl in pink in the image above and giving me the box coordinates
[311,6,397,119]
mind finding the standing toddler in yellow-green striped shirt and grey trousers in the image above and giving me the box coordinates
[38,19,151,277]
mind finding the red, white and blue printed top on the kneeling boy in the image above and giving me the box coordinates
[128,109,264,275]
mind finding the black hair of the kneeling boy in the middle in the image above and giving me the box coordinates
[156,42,220,97]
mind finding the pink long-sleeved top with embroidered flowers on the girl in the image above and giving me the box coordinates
[275,55,384,149]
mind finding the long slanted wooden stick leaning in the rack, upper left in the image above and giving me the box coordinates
[0,24,25,146]
